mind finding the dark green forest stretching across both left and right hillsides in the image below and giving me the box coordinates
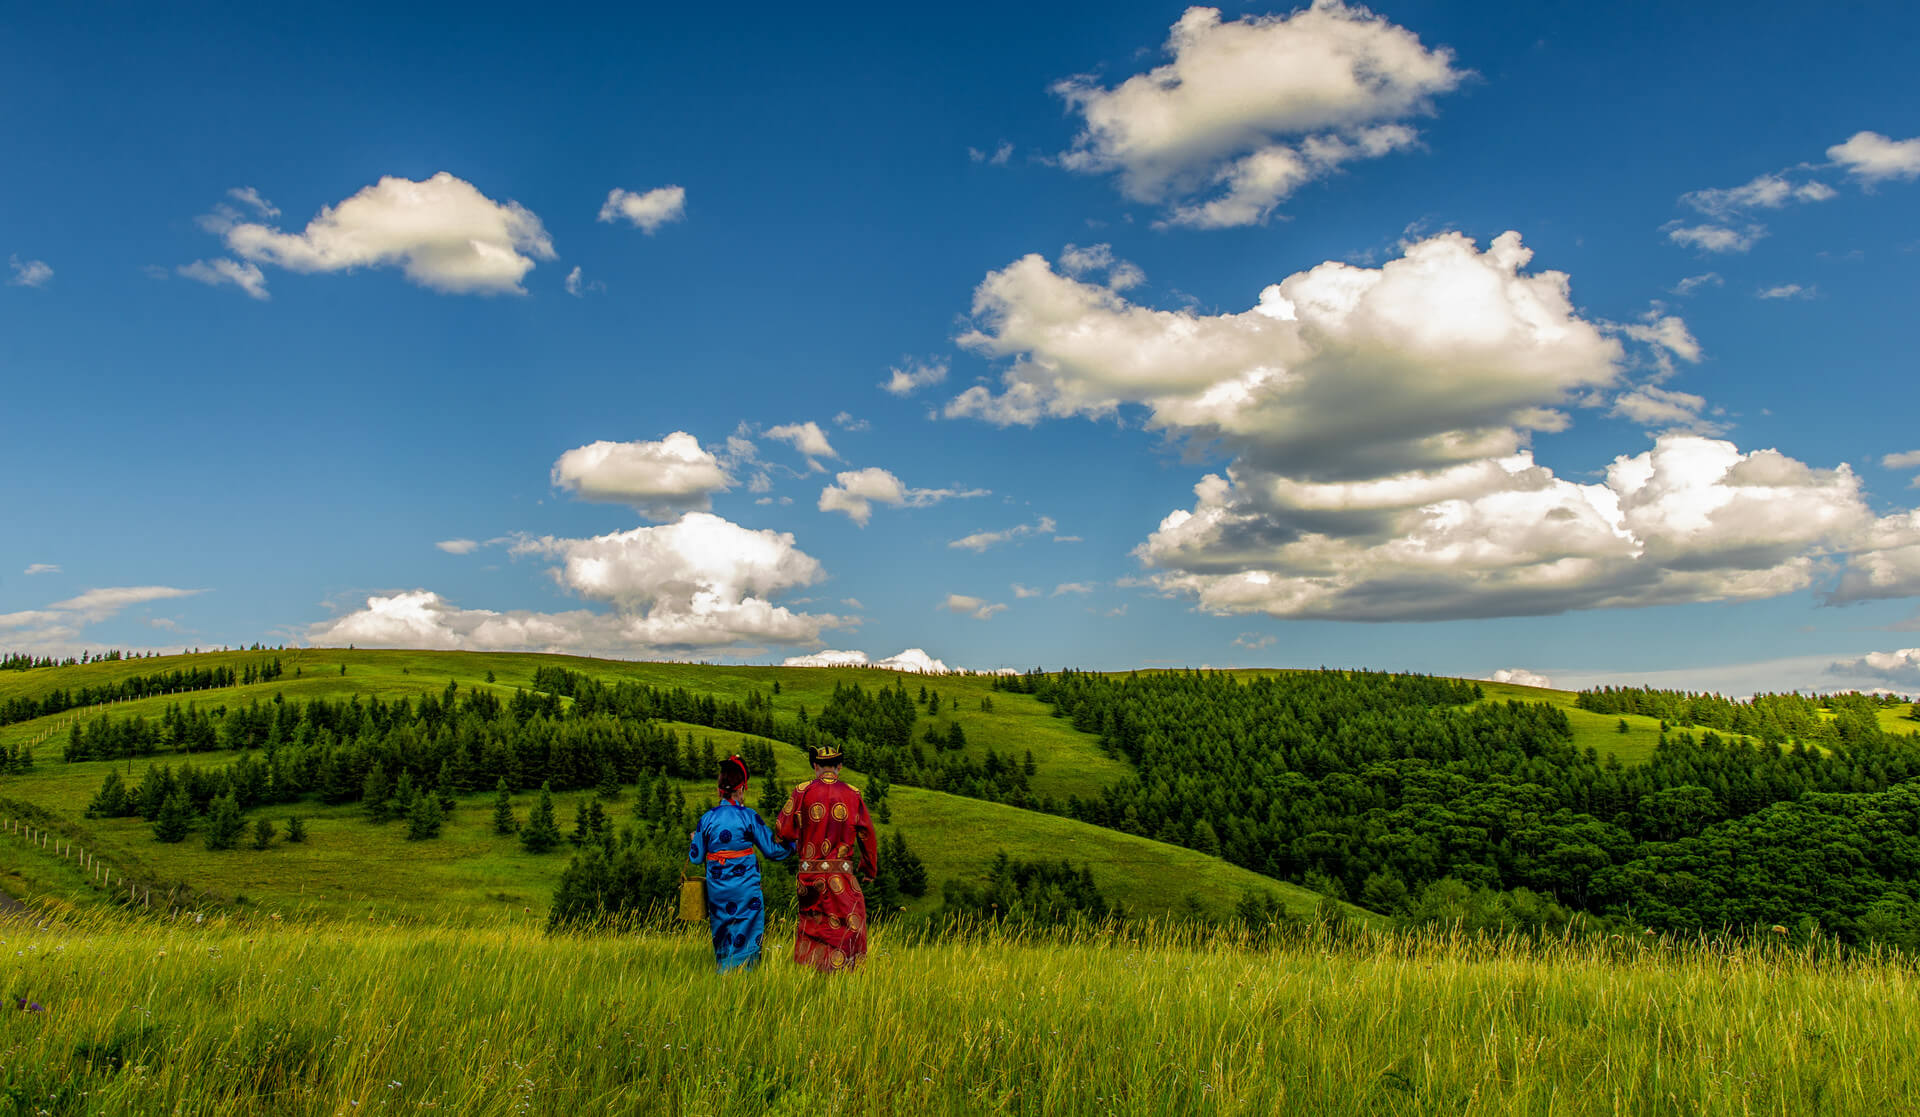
[33,666,1920,948]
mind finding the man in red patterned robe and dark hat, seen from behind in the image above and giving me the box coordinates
[776,745,879,973]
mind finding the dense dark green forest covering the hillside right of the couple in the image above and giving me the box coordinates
[1029,672,1920,935]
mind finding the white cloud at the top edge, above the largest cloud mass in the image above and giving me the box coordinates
[1054,0,1465,228]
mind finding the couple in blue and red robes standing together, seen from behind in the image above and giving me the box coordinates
[687,747,879,973]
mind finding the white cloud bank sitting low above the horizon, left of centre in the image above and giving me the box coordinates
[307,512,845,656]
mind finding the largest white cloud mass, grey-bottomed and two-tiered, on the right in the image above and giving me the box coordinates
[948,234,1920,620]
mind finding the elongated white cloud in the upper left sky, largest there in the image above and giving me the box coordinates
[208,171,555,297]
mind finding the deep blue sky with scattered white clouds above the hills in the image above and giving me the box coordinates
[0,2,1920,693]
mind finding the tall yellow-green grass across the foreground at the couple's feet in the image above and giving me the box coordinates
[0,915,1920,1115]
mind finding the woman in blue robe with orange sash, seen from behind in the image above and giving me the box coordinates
[687,756,793,973]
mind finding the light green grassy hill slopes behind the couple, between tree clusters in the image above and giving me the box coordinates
[0,651,1320,923]
